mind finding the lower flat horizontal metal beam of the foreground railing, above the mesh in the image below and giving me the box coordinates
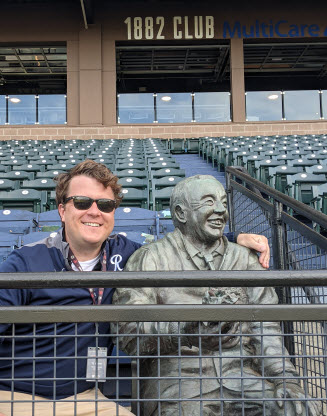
[0,304,327,324]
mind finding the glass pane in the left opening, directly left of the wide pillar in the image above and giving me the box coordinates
[39,94,66,124]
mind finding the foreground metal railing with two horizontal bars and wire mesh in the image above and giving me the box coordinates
[0,270,327,416]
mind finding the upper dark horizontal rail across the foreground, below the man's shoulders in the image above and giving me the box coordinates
[0,270,327,289]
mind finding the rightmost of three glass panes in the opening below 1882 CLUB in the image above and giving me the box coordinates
[194,92,230,122]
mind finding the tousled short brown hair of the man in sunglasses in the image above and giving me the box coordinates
[54,159,123,208]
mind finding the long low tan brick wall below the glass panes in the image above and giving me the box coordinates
[0,121,327,140]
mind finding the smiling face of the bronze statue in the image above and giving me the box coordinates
[186,179,228,244]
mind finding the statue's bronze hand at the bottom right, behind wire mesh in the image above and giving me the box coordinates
[275,381,322,416]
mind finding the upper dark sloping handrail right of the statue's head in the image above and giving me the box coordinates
[226,166,327,229]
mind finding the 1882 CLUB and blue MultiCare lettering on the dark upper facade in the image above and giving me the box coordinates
[124,16,327,40]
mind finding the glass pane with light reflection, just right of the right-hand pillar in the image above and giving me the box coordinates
[246,91,283,121]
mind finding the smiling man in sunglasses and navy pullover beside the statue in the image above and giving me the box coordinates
[0,160,269,416]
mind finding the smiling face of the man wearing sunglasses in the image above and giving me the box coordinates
[59,175,115,256]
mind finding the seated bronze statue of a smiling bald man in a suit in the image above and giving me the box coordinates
[113,175,320,416]
